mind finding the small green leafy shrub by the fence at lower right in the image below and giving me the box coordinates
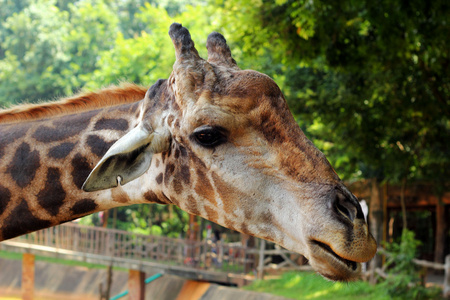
[380,229,441,299]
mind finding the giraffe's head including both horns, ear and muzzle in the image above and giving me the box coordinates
[83,24,376,281]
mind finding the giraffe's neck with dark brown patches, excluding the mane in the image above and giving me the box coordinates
[0,92,172,240]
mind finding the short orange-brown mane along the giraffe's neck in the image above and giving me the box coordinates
[0,83,148,123]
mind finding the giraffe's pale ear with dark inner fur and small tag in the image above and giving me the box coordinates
[82,124,170,192]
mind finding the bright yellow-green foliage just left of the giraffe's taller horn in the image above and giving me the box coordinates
[81,4,175,89]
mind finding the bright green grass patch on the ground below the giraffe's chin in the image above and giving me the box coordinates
[244,272,390,300]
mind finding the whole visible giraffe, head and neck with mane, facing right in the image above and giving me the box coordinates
[0,23,376,281]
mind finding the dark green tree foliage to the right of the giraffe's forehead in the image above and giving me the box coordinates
[217,0,450,190]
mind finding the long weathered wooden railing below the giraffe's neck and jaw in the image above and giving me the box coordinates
[13,223,253,273]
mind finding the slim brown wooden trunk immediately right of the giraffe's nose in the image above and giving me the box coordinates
[369,178,384,284]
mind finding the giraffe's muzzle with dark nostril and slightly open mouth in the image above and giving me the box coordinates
[302,185,377,281]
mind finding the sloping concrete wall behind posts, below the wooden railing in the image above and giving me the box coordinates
[0,259,285,300]
